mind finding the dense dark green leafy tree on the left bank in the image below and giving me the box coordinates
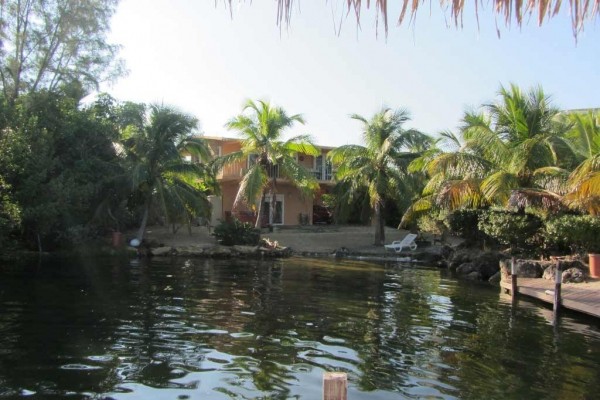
[0,91,119,250]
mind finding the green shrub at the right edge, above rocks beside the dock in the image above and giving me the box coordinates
[545,215,600,253]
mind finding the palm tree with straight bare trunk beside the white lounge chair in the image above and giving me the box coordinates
[328,108,430,246]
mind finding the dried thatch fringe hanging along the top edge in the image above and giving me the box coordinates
[223,0,600,38]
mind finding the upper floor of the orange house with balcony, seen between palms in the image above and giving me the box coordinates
[203,136,335,183]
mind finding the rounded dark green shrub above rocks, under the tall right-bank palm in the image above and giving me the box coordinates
[478,210,543,248]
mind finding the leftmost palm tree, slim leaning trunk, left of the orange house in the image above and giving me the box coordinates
[123,105,215,241]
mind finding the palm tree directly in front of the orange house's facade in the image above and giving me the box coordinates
[215,100,319,228]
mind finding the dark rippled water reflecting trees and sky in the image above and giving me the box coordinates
[0,255,600,400]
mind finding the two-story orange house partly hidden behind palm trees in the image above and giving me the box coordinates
[203,136,334,226]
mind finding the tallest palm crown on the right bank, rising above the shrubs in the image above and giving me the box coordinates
[462,85,576,205]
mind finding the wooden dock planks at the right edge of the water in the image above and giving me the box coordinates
[500,278,600,318]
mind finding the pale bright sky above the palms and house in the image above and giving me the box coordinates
[101,0,600,146]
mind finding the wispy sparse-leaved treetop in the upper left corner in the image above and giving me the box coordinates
[0,0,123,103]
